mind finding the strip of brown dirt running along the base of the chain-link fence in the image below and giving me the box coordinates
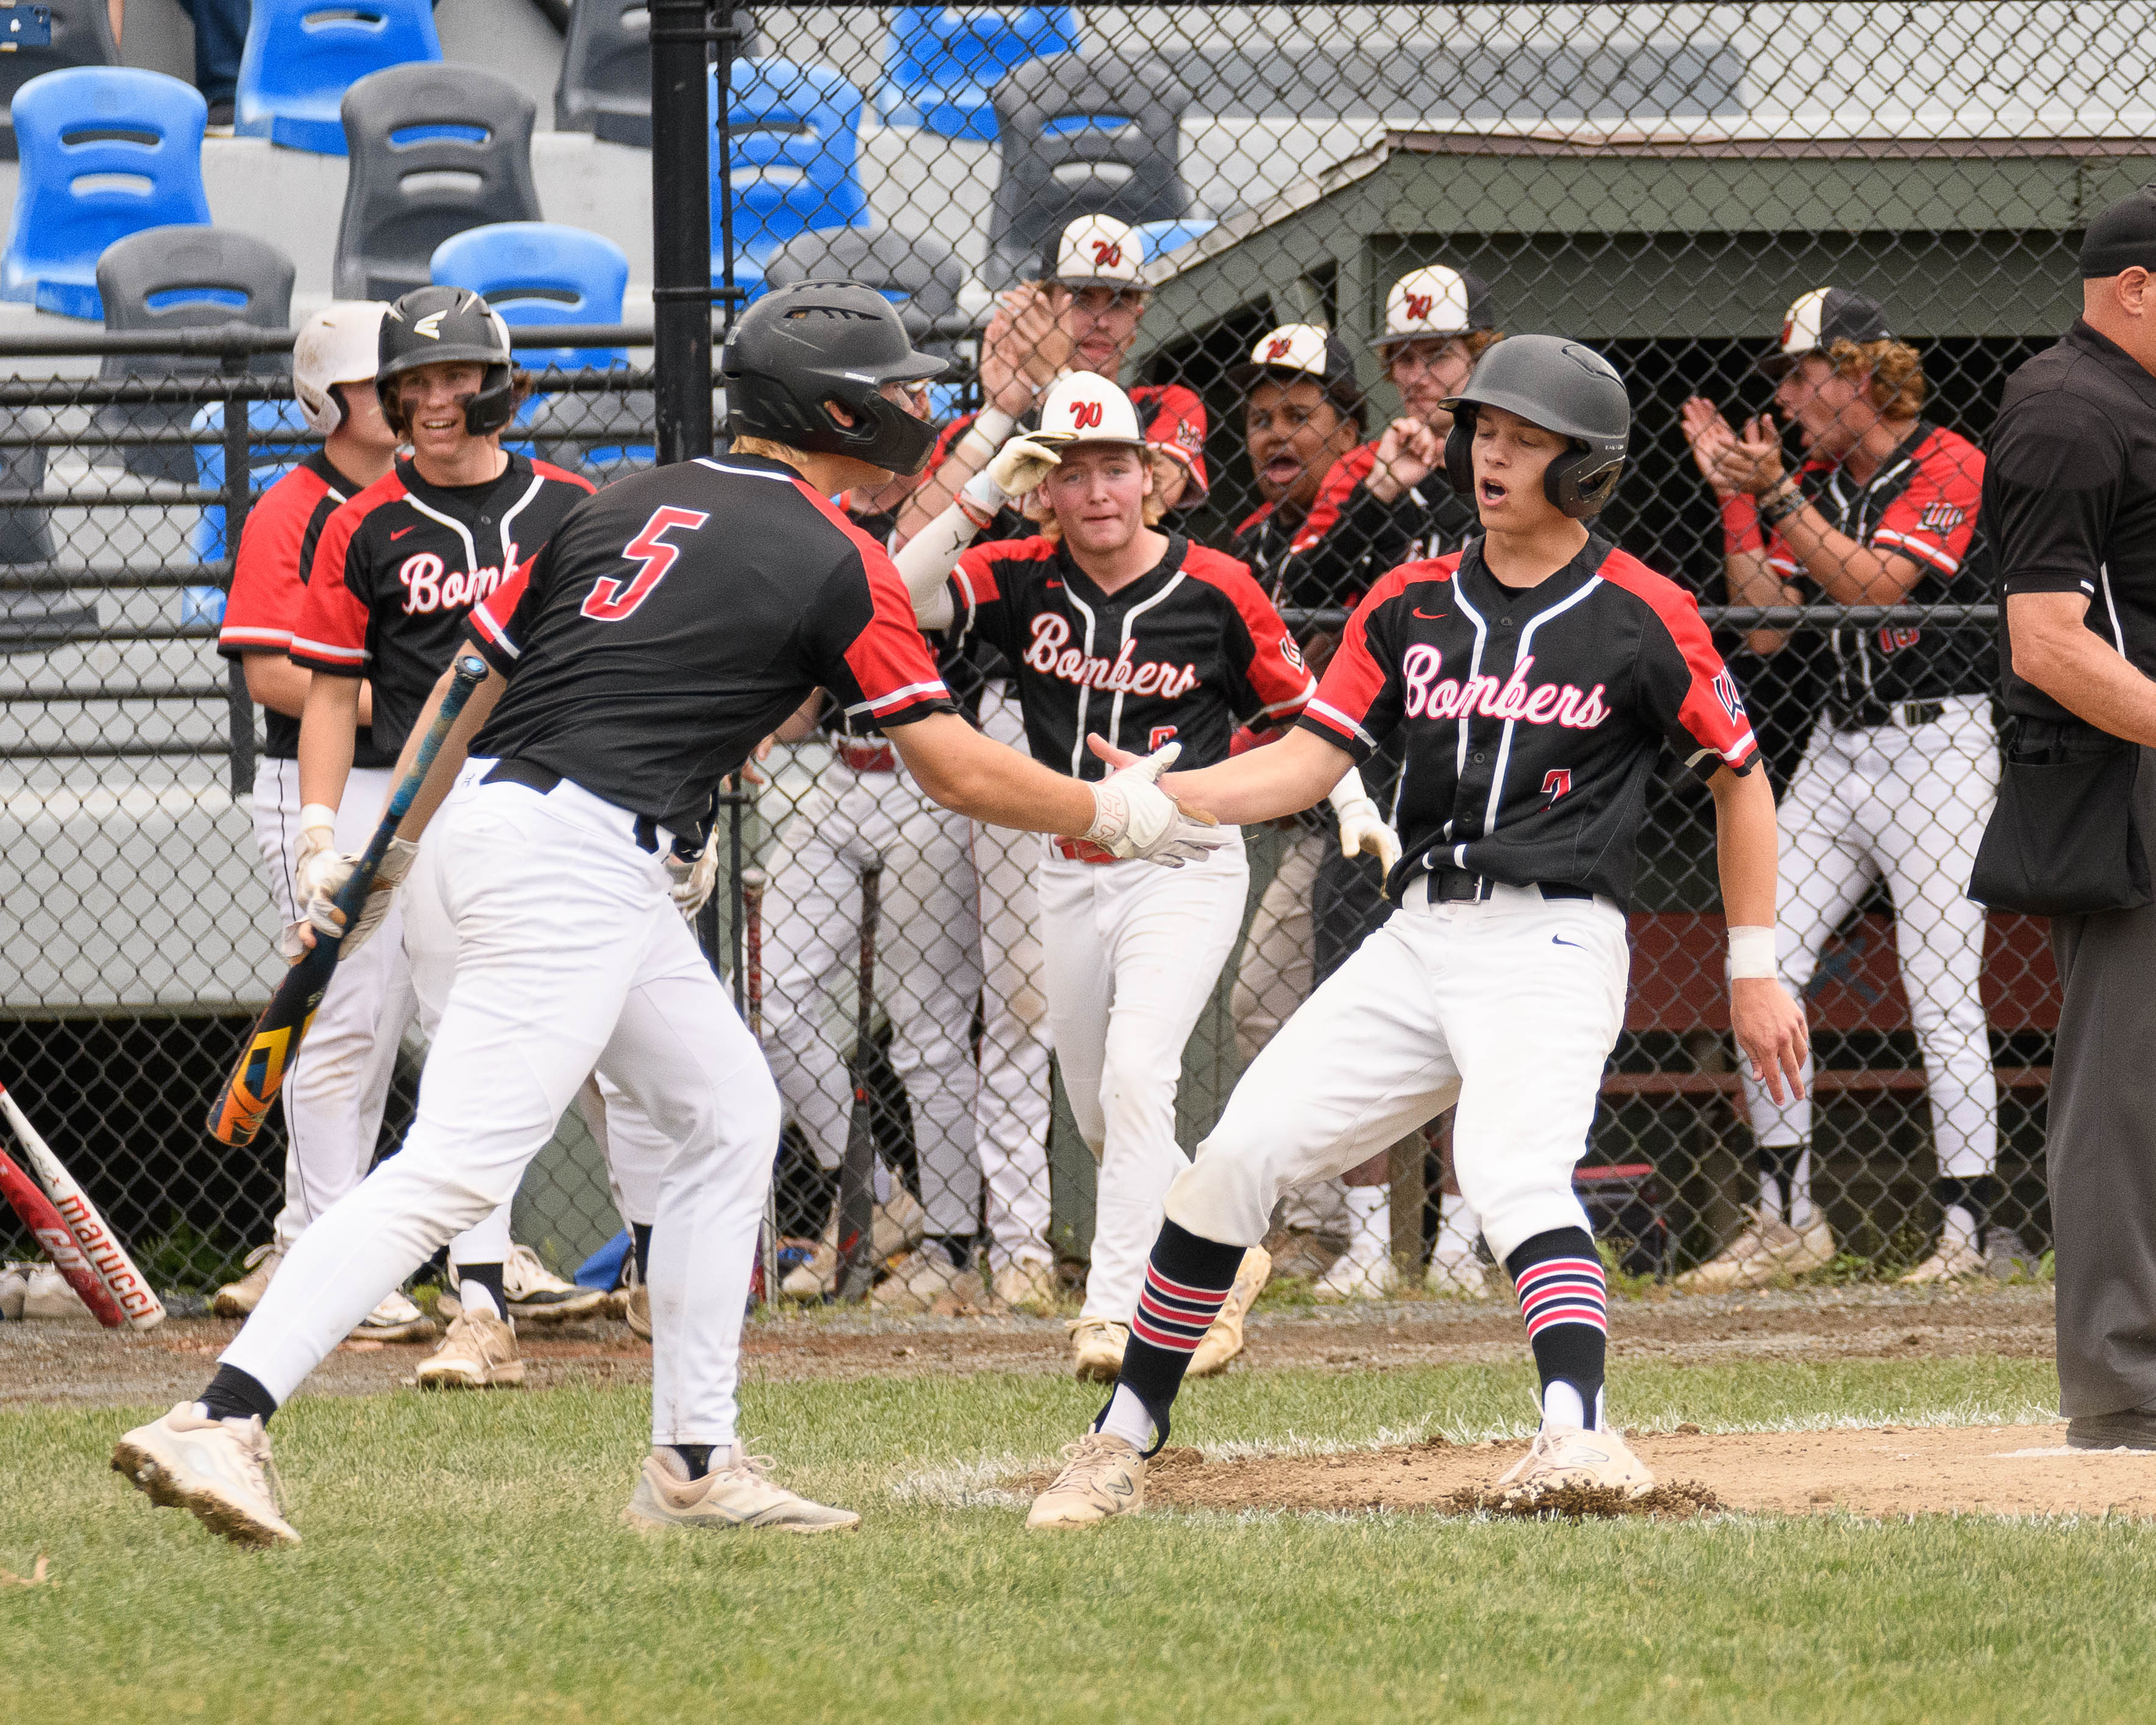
[0,1287,2052,1406]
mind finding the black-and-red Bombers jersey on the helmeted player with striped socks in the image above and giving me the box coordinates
[1300,537,1759,906]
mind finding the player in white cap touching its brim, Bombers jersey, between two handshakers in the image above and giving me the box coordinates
[899,373,1315,1380]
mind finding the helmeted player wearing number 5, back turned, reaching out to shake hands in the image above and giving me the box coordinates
[115,282,1231,1544]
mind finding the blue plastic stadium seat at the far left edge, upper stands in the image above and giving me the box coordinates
[0,67,209,317]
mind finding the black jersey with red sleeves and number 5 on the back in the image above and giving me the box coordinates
[466,455,955,832]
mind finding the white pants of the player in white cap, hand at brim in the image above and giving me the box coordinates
[1037,832,1272,1324]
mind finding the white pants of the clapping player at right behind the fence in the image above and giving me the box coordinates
[1744,694,1999,1179]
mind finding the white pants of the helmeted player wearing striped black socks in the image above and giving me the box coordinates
[1166,882,1630,1264]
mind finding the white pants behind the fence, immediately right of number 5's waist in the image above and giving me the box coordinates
[763,759,981,1233]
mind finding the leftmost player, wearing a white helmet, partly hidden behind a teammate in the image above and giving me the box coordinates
[216,300,433,1341]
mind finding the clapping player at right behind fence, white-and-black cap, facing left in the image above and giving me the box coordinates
[1682,286,2029,1292]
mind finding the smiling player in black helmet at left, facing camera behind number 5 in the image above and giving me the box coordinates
[289,286,608,1389]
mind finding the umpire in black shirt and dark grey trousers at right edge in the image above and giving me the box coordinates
[1971,190,2156,1449]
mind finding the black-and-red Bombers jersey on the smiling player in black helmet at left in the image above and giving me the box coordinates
[289,455,590,761]
